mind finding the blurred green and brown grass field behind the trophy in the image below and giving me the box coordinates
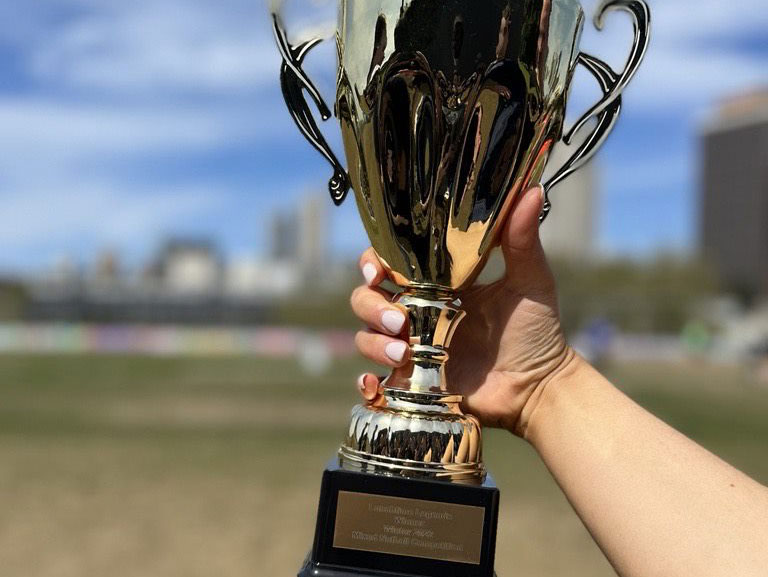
[0,356,768,577]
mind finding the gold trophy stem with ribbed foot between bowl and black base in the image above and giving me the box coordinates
[339,287,485,484]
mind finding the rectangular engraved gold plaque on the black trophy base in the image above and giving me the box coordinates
[333,491,485,565]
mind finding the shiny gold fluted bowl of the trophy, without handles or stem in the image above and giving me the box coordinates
[336,0,584,291]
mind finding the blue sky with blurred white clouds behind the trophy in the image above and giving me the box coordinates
[0,0,768,272]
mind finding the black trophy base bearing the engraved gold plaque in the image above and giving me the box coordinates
[298,463,499,577]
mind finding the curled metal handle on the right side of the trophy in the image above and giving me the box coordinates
[539,0,651,222]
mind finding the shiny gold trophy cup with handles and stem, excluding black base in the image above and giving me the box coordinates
[274,0,650,482]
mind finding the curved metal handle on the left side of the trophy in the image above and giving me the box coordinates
[272,13,349,206]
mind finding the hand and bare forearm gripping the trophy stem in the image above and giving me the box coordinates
[351,187,768,577]
